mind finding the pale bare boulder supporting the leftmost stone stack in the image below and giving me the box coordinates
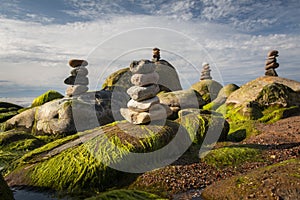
[3,91,114,135]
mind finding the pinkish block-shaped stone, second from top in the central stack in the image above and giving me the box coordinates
[131,72,159,86]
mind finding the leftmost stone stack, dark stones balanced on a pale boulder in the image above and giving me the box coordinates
[64,59,89,97]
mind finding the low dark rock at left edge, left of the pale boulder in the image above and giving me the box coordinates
[0,102,23,123]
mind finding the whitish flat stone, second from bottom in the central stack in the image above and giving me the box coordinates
[127,96,159,112]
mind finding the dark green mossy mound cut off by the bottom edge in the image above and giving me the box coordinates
[86,189,168,200]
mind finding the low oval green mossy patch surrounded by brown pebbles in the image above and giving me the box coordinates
[202,146,261,168]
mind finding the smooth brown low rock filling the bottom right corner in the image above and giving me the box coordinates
[202,159,300,200]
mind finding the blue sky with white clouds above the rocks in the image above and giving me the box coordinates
[0,0,300,105]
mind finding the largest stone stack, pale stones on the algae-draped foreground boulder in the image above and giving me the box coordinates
[120,60,172,124]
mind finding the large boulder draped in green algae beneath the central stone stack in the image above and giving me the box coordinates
[7,121,190,193]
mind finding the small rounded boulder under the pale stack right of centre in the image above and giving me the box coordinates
[191,79,223,103]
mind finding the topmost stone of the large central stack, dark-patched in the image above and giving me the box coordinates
[129,60,156,74]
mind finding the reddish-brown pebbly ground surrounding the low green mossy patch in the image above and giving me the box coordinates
[129,116,300,199]
